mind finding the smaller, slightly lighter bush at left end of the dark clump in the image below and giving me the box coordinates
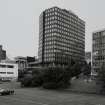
[21,69,43,87]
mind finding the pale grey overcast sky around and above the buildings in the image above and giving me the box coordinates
[0,0,105,57]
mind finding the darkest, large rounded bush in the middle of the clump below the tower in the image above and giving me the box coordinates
[43,67,71,89]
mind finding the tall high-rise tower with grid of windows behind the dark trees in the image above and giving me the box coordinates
[38,7,85,65]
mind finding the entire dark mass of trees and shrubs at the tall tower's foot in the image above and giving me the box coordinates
[21,63,81,89]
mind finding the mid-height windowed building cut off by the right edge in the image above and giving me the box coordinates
[92,29,105,73]
